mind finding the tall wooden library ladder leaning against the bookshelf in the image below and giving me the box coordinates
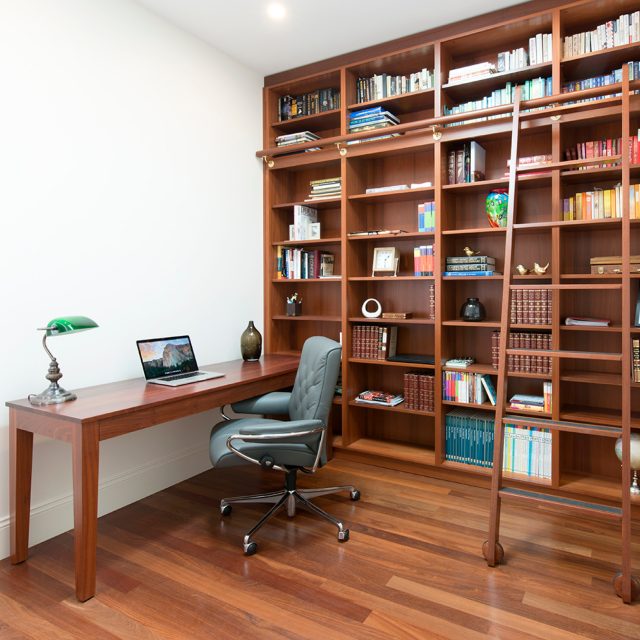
[482,72,640,603]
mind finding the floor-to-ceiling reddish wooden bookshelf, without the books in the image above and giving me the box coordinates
[257,0,640,595]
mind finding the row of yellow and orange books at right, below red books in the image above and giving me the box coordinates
[562,184,640,220]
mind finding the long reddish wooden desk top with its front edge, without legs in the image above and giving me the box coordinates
[6,354,300,422]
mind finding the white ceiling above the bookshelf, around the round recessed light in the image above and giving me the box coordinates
[132,0,522,75]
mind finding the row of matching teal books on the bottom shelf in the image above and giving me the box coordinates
[445,409,495,468]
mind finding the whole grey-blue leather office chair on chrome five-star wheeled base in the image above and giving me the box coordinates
[209,336,360,555]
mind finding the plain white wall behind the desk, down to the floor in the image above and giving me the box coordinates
[0,0,262,558]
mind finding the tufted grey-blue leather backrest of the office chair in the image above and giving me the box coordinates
[289,336,342,426]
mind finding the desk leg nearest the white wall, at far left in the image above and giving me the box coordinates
[9,409,33,564]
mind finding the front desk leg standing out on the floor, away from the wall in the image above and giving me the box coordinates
[72,423,100,602]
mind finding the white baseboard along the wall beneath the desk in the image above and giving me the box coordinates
[0,442,211,559]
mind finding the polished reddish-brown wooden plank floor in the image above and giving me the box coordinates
[0,460,640,640]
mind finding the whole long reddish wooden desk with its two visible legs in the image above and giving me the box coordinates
[6,355,299,602]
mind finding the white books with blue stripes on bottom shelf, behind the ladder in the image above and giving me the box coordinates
[502,424,551,479]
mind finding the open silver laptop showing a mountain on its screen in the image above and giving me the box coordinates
[136,336,224,387]
